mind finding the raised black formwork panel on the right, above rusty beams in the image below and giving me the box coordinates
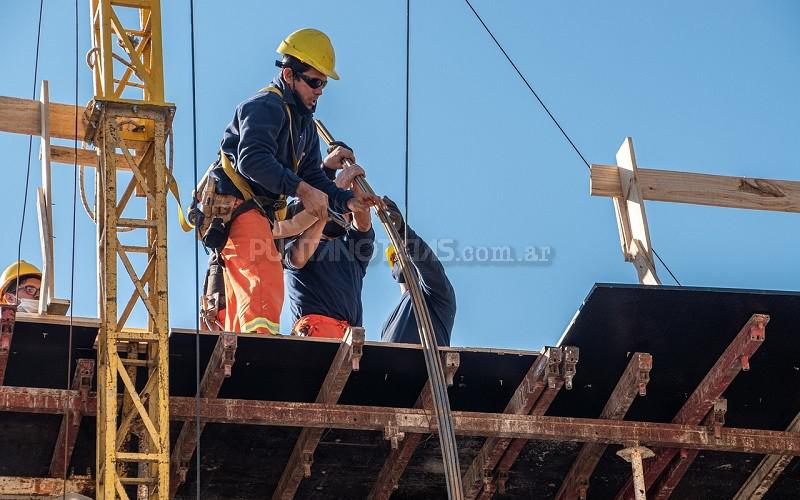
[504,284,800,499]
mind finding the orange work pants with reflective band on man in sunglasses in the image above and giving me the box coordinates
[221,210,283,335]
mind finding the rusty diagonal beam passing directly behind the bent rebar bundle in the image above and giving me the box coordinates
[367,351,461,500]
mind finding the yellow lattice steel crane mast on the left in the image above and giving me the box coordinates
[87,0,175,499]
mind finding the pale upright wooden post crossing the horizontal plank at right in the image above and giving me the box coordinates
[613,137,661,285]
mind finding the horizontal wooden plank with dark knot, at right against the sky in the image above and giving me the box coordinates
[591,165,800,213]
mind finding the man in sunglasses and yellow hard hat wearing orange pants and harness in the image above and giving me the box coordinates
[204,29,380,334]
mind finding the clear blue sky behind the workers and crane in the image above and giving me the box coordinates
[0,0,800,349]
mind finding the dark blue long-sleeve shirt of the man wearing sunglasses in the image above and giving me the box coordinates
[212,77,353,213]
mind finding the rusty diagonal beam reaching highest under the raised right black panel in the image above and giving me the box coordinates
[615,314,769,500]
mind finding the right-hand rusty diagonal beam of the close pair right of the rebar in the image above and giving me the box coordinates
[480,346,579,500]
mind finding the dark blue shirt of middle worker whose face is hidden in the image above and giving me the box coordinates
[284,228,375,326]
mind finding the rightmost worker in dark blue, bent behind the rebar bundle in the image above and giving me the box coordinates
[381,197,456,346]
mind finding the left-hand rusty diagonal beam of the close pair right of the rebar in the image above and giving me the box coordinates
[461,347,563,499]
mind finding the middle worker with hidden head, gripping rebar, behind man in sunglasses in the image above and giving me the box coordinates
[284,165,375,338]
